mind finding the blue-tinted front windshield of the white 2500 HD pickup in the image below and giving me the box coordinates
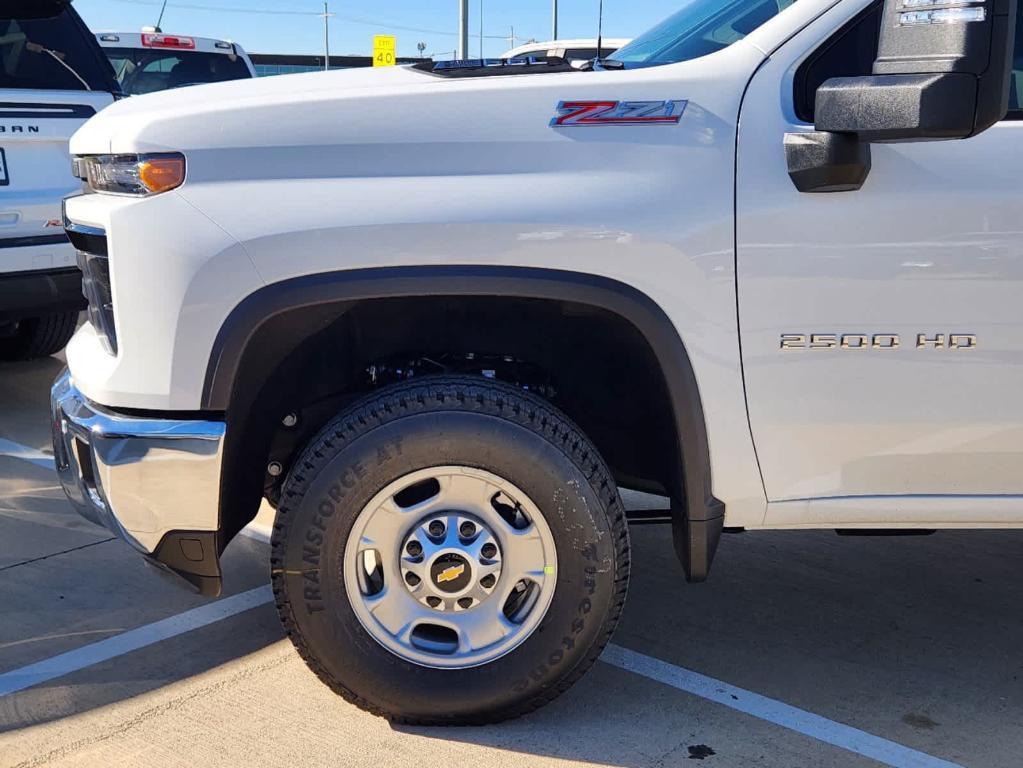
[609,0,795,67]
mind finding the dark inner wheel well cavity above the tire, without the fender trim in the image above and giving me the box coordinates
[225,297,681,539]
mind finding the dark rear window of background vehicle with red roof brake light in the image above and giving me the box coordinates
[103,48,252,96]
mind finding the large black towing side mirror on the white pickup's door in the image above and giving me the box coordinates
[786,0,1017,192]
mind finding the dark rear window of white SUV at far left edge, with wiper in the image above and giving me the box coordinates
[0,1,114,91]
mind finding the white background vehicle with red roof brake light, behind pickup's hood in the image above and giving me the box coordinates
[96,31,256,96]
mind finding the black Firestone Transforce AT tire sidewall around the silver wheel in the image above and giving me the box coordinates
[275,410,618,721]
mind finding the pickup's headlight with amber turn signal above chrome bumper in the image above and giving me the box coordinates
[75,152,185,196]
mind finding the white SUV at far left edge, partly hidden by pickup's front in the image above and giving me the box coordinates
[0,0,118,359]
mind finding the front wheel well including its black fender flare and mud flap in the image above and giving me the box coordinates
[204,268,723,580]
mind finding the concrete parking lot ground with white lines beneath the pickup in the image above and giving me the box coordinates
[0,359,1023,768]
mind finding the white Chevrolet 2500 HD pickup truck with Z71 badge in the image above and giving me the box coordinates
[52,0,1023,724]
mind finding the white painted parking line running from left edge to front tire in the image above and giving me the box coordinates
[0,585,273,696]
